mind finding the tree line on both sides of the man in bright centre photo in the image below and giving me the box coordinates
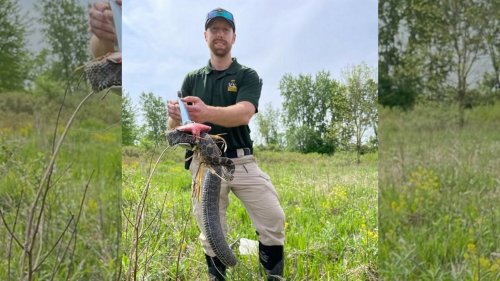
[122,64,378,159]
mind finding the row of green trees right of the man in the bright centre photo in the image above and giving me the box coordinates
[256,63,378,159]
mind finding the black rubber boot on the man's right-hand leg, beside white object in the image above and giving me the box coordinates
[259,241,285,281]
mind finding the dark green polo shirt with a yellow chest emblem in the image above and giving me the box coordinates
[182,58,262,149]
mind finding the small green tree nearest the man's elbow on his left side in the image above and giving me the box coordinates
[140,93,167,144]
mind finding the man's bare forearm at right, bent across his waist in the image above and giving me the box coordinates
[207,101,255,128]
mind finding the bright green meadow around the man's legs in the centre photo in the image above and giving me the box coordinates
[122,147,378,280]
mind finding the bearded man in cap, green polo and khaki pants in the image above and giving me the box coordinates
[167,8,285,280]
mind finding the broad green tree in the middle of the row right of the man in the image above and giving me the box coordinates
[280,71,345,154]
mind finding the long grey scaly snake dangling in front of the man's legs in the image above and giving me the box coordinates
[166,123,238,266]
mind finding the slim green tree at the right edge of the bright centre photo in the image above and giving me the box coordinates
[342,64,378,164]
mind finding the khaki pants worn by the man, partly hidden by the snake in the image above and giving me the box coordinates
[189,153,285,257]
